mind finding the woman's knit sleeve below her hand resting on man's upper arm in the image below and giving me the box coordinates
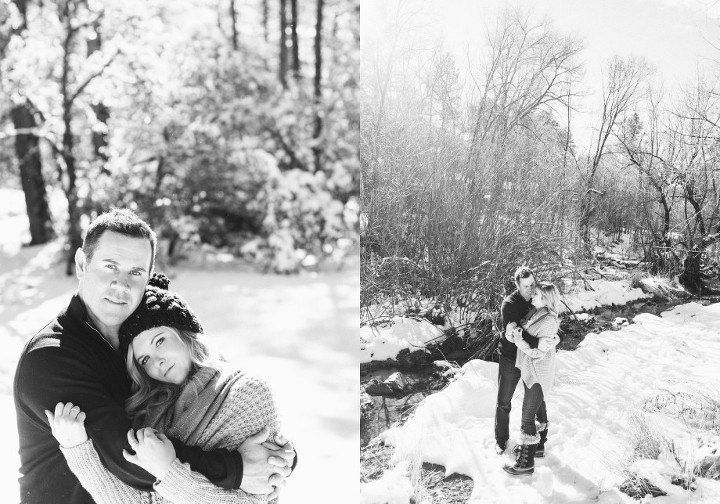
[60,439,150,504]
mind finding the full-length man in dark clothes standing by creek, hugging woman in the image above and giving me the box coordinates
[495,266,538,454]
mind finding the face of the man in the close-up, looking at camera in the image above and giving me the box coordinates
[75,231,152,336]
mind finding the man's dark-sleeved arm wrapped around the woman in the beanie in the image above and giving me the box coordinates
[18,346,242,490]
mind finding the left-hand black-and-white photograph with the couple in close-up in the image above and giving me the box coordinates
[0,0,360,504]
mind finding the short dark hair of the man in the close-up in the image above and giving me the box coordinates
[82,208,157,275]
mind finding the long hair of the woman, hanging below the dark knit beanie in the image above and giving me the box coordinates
[125,327,217,428]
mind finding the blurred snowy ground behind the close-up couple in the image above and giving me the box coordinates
[0,190,360,503]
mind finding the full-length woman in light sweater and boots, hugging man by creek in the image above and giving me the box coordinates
[503,284,560,476]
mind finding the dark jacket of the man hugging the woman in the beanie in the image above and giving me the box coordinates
[13,294,242,504]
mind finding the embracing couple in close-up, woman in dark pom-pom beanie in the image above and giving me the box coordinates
[13,210,297,504]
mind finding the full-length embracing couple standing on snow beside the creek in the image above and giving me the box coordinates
[495,266,561,476]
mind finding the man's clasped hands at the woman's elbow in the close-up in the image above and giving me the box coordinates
[238,427,295,495]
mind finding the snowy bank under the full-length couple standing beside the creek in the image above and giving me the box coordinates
[361,303,720,504]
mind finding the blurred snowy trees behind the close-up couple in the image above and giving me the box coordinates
[0,0,360,271]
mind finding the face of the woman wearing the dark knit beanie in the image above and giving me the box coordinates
[132,326,192,385]
